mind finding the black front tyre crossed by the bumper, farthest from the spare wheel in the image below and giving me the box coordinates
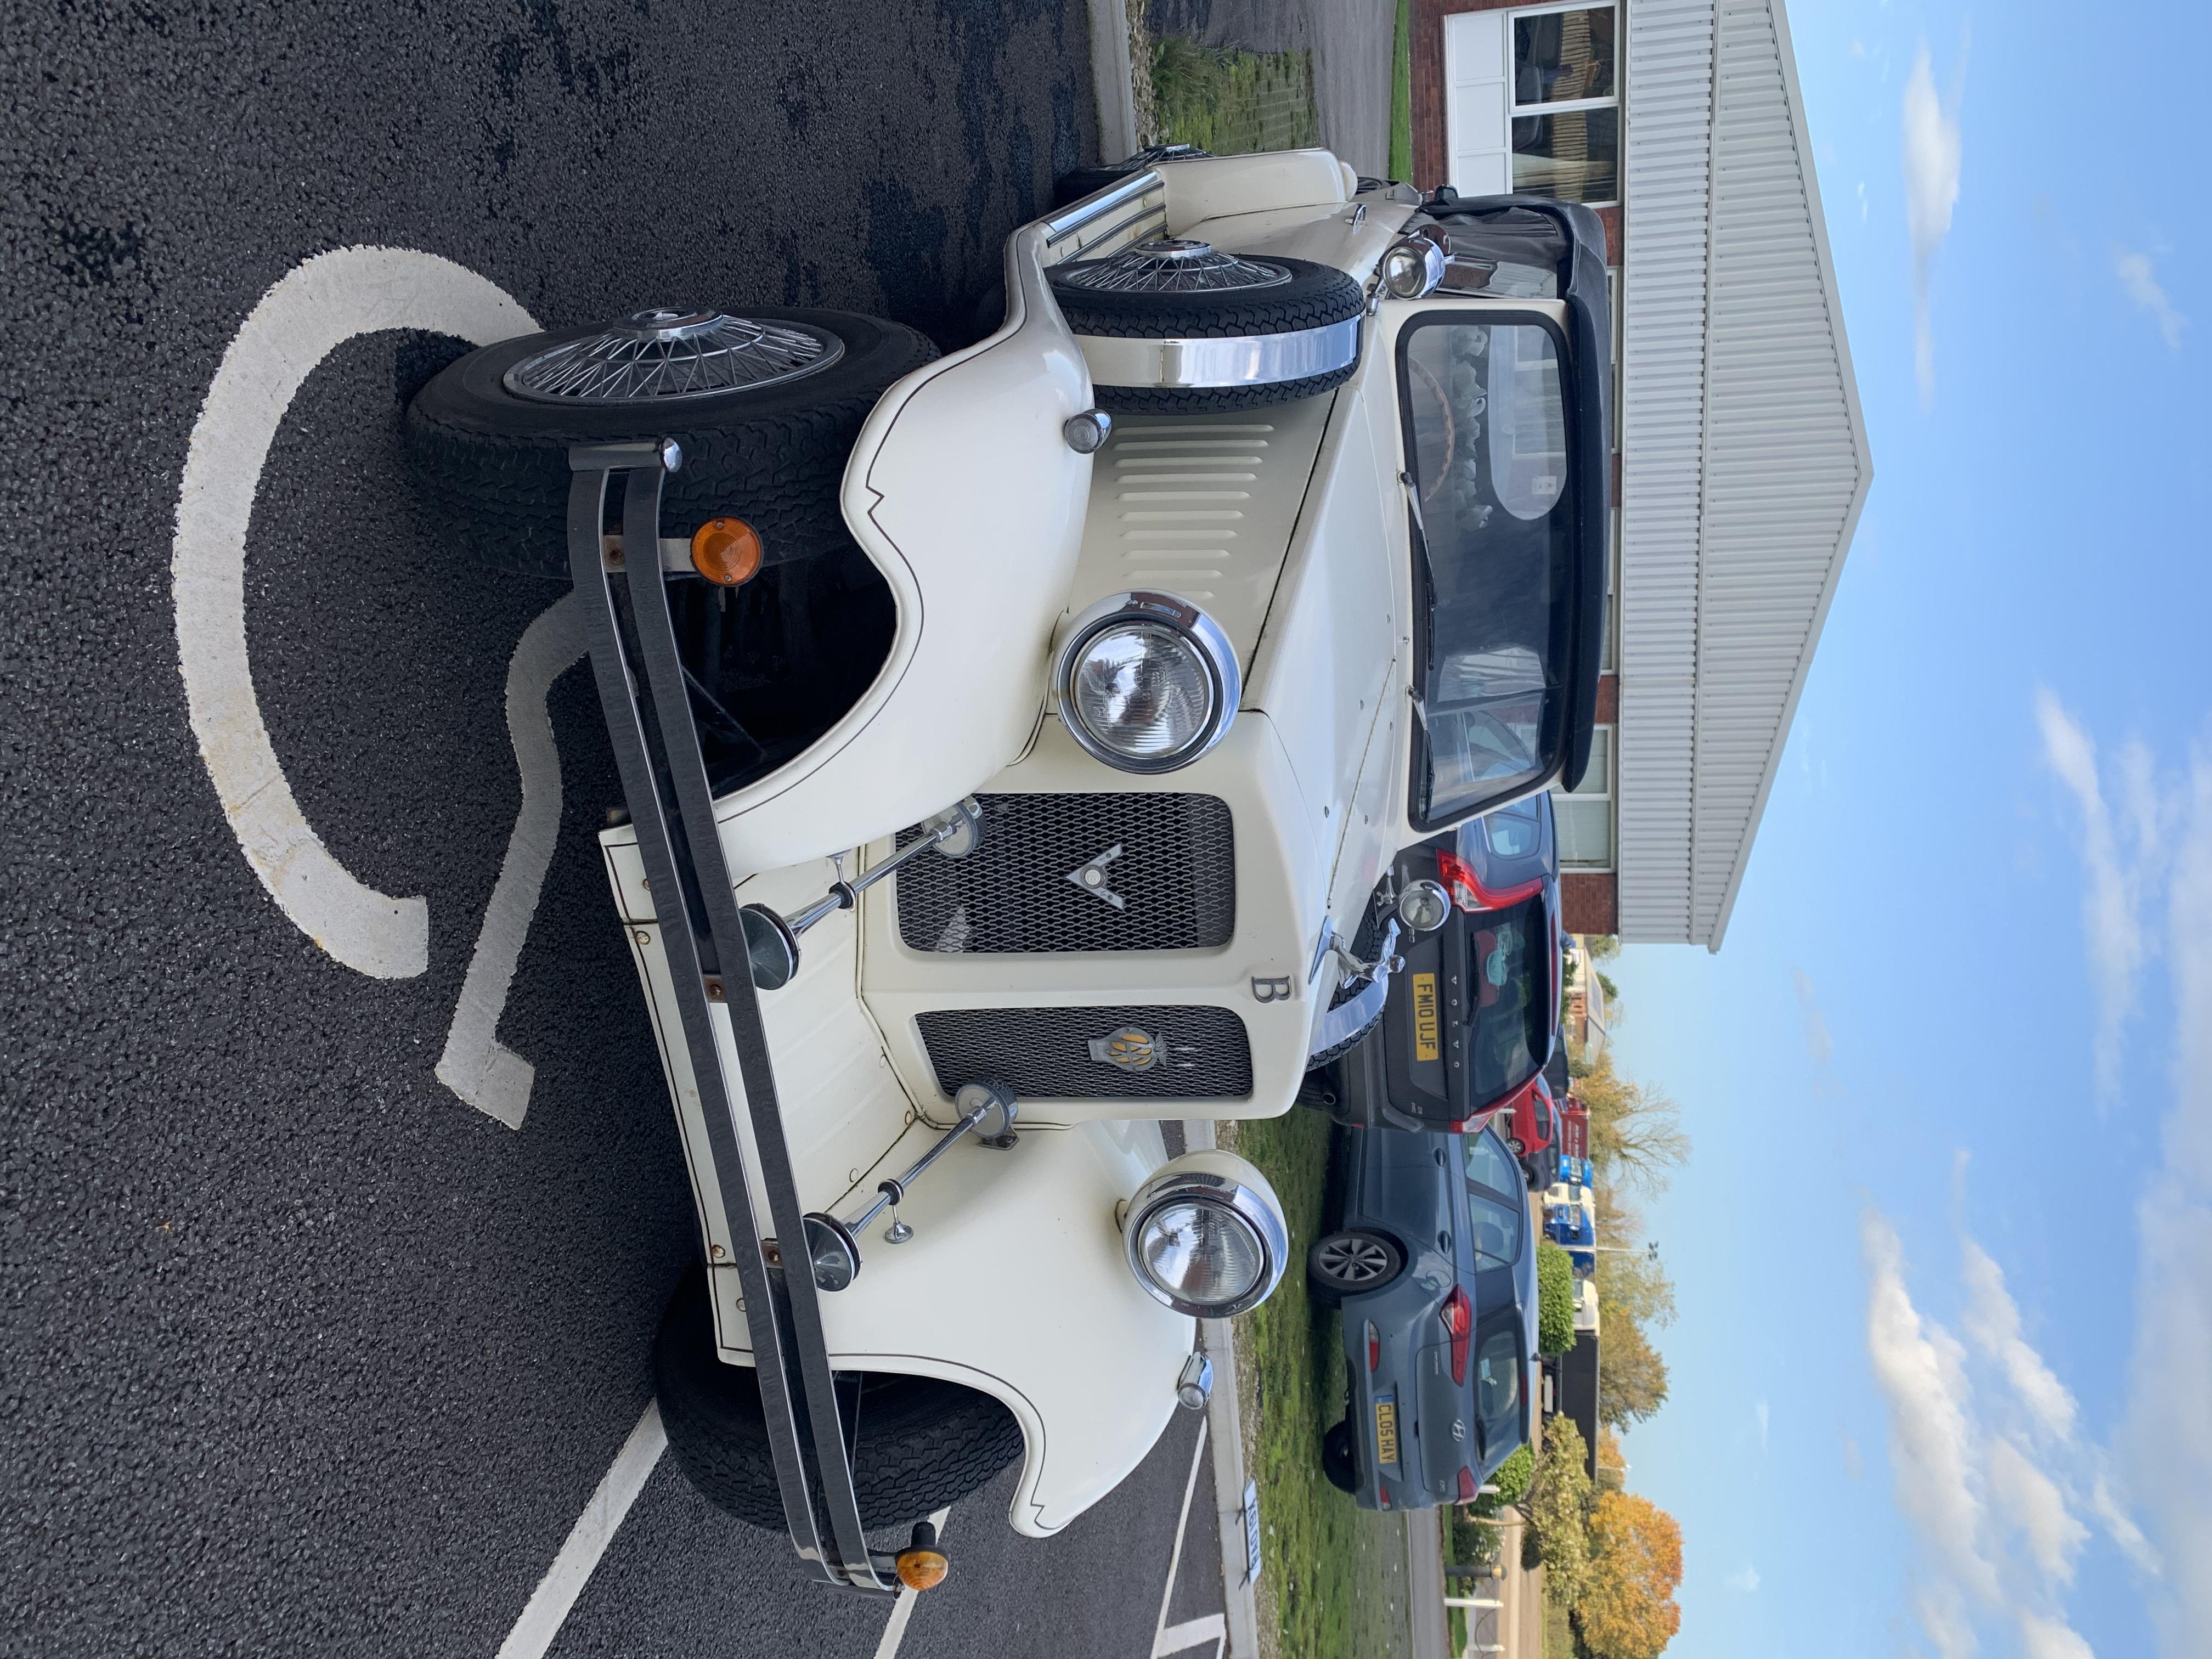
[652,1265,1022,1533]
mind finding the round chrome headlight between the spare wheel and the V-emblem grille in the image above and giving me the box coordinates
[1053,593,1243,772]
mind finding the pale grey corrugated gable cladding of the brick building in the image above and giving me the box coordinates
[1617,0,1874,949]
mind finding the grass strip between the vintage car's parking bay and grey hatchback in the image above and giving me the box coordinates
[1237,1108,1411,1659]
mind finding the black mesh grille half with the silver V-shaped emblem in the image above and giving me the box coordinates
[896,794,1237,953]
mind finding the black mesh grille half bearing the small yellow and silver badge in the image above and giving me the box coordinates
[920,1009,1252,1099]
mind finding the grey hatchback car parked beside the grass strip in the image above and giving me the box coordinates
[1305,1128,1537,1509]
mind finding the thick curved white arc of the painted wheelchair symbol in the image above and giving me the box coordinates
[170,248,538,980]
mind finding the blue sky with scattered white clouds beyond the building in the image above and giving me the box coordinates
[1615,0,2212,1659]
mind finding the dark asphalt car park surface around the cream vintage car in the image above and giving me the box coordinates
[0,13,1248,1659]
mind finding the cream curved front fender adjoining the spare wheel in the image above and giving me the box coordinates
[714,225,1091,874]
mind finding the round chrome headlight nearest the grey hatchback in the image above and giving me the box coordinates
[1121,1153,1290,1318]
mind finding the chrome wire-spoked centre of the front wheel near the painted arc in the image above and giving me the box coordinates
[500,309,845,403]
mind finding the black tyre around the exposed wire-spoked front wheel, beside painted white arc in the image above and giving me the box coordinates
[407,305,938,582]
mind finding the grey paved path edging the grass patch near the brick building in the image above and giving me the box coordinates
[1146,0,1398,179]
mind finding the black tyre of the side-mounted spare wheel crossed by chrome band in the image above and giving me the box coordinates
[1046,255,1367,414]
